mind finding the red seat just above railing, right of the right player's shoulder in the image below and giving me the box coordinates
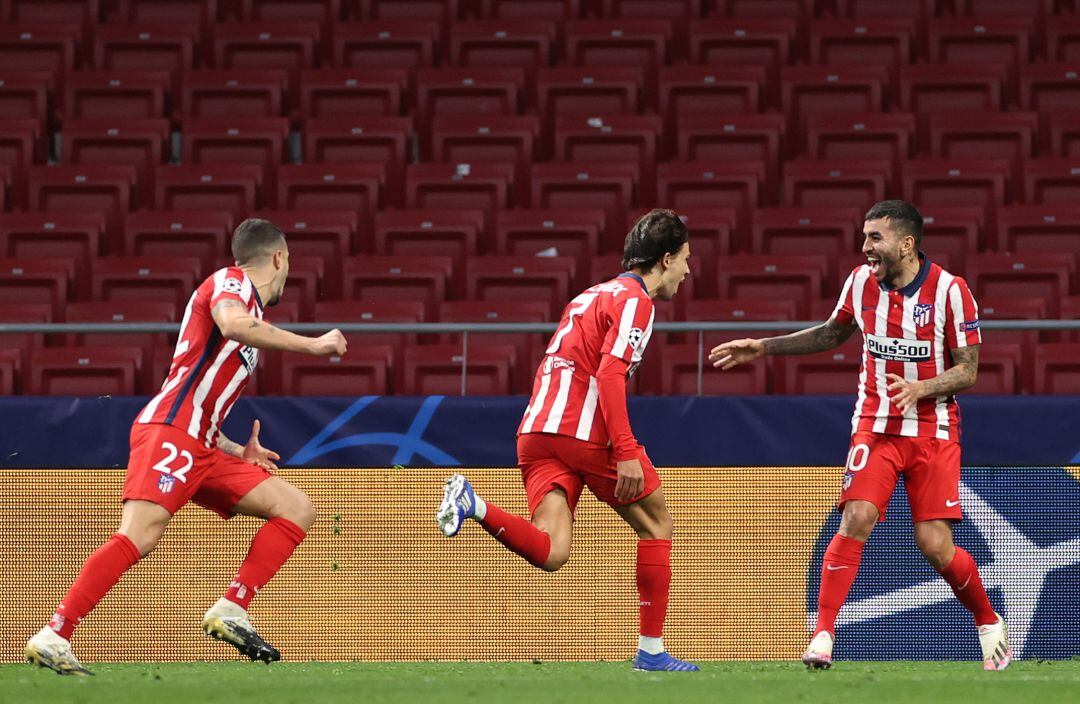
[968,252,1076,317]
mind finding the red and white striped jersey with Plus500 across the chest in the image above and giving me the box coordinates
[833,254,983,441]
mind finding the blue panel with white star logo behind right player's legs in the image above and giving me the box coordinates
[807,468,1080,660]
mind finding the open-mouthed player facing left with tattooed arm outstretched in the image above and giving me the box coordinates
[710,201,1012,669]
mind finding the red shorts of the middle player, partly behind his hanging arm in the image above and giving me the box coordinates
[517,433,660,515]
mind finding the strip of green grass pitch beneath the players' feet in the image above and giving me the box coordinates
[0,660,1080,704]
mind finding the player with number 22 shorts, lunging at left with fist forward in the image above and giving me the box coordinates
[25,219,346,675]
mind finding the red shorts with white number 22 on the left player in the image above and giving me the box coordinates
[124,423,271,518]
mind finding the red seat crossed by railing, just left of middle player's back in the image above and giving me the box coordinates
[438,300,551,394]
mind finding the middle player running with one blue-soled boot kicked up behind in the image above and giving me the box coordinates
[435,209,698,671]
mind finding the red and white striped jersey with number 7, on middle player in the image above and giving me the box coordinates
[517,273,653,445]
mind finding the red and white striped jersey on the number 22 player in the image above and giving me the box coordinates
[135,267,262,447]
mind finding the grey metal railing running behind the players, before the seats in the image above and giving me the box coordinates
[0,320,1080,396]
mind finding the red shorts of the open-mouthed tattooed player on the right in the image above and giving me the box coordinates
[837,432,963,523]
